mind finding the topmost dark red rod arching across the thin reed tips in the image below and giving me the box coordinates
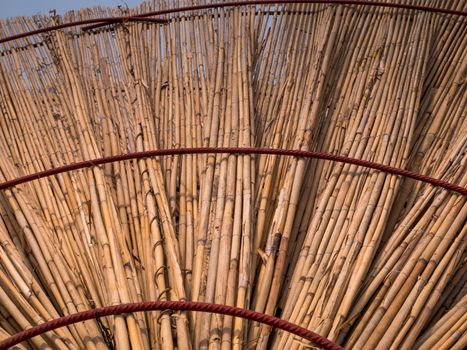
[0,0,467,44]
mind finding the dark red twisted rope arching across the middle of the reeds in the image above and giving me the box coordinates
[0,147,467,196]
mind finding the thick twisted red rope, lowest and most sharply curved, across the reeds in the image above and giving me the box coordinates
[0,301,344,350]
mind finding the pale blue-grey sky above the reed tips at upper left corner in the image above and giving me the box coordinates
[0,0,143,18]
